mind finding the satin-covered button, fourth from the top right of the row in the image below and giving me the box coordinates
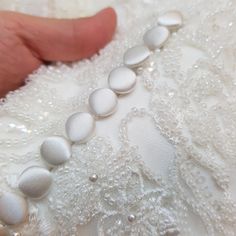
[108,66,136,94]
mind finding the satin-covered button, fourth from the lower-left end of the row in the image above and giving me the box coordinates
[65,112,95,143]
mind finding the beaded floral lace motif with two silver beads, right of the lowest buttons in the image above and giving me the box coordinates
[48,138,180,236]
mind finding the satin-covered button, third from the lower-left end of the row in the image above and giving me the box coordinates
[40,136,71,166]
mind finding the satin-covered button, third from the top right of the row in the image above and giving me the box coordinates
[124,45,150,68]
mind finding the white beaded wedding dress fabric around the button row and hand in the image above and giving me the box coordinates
[0,0,236,236]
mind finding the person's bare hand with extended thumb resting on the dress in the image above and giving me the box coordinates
[0,8,116,97]
